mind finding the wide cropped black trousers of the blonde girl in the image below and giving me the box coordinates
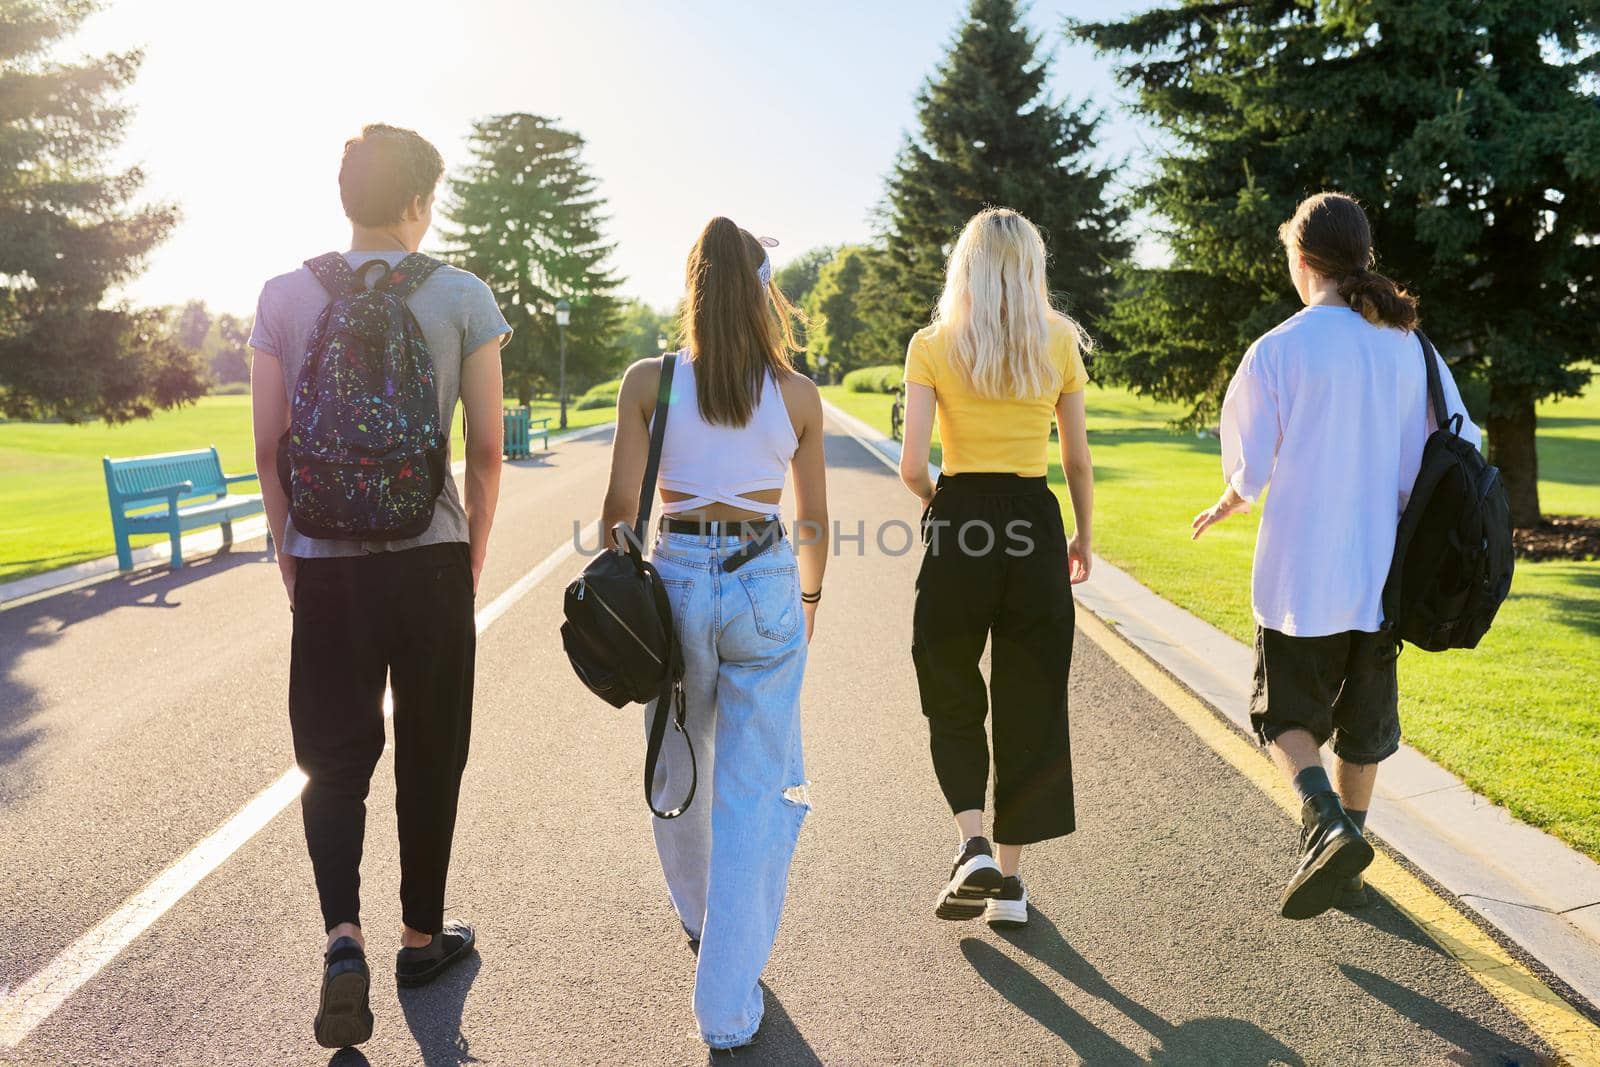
[912,474,1075,845]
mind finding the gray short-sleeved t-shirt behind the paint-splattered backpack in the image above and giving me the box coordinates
[250,251,510,557]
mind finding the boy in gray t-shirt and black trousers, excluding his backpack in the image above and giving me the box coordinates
[250,125,510,1048]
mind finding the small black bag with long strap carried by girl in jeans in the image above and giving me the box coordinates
[562,355,699,819]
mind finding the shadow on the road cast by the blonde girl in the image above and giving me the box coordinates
[962,909,1306,1067]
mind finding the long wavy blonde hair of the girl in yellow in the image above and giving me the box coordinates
[934,208,1090,400]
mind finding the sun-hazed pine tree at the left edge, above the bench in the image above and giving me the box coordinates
[0,0,206,422]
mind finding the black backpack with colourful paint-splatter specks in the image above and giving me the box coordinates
[278,253,448,541]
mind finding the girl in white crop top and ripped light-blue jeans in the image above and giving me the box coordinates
[602,218,827,1048]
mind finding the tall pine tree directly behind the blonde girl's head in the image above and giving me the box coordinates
[870,0,1128,358]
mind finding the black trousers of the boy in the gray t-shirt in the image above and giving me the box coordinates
[290,542,477,934]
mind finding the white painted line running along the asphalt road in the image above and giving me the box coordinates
[0,523,598,1048]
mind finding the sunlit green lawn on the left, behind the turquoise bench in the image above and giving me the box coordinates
[0,397,613,581]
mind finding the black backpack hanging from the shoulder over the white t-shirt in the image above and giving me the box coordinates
[1384,331,1515,653]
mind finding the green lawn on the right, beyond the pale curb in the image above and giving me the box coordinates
[822,379,1600,859]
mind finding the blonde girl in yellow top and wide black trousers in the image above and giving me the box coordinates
[901,208,1094,926]
